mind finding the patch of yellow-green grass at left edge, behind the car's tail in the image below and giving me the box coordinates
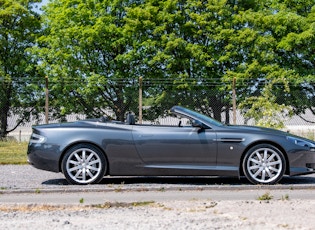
[0,140,28,165]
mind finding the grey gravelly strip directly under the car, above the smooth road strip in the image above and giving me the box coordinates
[0,165,315,193]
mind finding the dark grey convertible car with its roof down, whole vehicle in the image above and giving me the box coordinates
[27,106,315,185]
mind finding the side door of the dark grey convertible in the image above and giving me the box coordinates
[132,125,217,169]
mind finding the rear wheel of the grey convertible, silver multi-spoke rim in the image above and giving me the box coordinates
[61,144,107,185]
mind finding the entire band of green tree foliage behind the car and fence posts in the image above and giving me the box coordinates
[0,0,315,136]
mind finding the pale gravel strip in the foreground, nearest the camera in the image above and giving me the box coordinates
[0,200,315,230]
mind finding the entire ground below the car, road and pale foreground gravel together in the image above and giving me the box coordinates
[0,165,315,230]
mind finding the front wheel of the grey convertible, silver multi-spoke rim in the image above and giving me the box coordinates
[243,144,286,184]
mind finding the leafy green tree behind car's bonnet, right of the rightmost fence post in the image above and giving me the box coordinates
[229,0,315,125]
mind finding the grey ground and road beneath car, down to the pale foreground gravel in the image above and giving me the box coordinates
[0,165,315,204]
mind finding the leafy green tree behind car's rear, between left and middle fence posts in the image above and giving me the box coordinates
[37,0,138,120]
